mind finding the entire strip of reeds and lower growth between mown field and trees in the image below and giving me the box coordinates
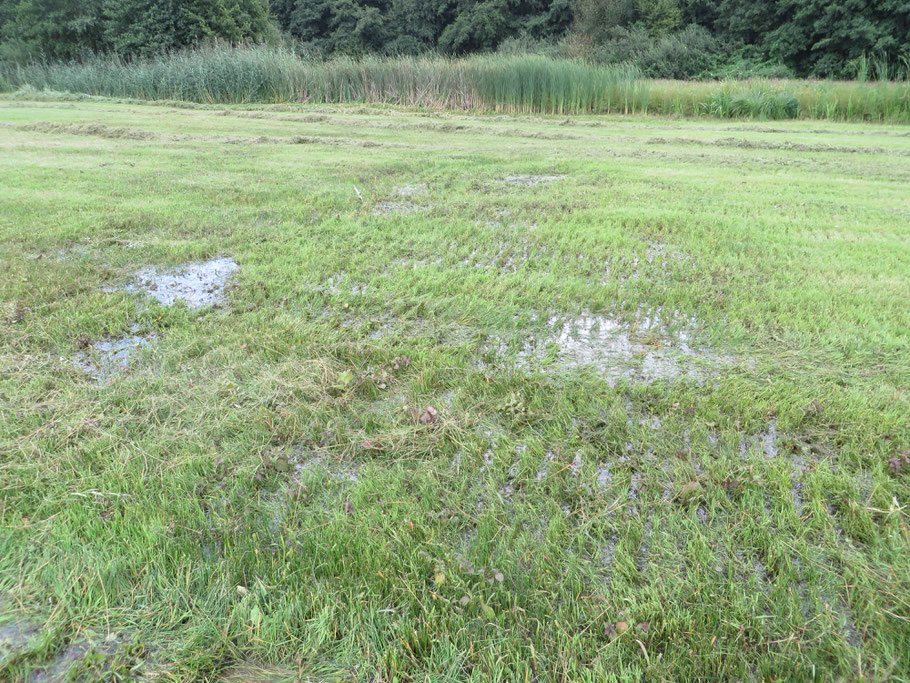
[0,45,910,122]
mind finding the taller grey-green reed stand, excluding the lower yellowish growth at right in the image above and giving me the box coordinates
[0,45,647,114]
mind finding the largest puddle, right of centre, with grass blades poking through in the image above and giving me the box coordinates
[518,313,733,385]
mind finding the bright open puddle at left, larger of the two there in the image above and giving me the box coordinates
[125,258,238,308]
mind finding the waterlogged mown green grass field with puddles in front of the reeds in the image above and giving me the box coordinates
[0,98,910,681]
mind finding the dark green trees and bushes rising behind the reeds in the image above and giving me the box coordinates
[0,0,910,78]
